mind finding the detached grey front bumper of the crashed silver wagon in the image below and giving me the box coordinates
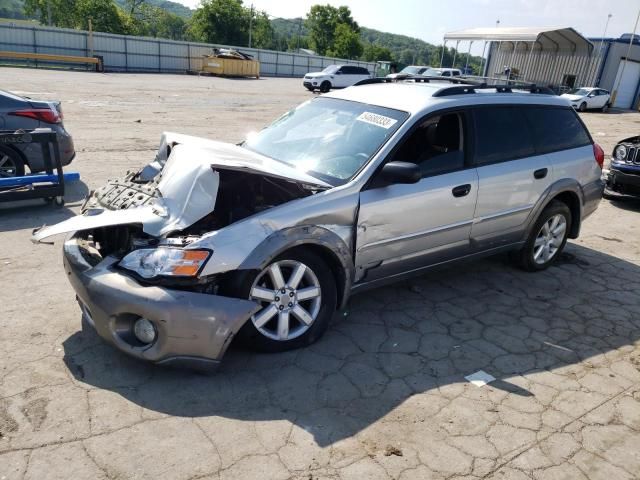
[64,238,260,369]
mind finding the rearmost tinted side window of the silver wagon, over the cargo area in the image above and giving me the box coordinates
[525,107,591,153]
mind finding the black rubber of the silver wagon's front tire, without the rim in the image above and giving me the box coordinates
[233,248,337,352]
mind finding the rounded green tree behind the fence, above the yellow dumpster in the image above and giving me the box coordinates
[188,0,249,45]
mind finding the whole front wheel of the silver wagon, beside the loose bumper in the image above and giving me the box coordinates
[238,249,337,352]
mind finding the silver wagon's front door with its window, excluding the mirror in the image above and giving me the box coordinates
[356,113,478,283]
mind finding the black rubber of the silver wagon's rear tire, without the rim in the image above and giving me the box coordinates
[515,200,572,272]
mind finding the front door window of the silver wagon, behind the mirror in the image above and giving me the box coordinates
[392,113,464,178]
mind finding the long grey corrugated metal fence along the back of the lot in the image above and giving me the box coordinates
[0,23,375,77]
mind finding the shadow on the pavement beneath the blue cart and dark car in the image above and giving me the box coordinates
[0,181,89,232]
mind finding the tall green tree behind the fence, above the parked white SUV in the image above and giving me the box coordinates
[305,5,360,55]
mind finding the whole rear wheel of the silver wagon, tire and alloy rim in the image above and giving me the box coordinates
[517,200,572,272]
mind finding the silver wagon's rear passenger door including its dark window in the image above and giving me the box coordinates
[471,105,553,250]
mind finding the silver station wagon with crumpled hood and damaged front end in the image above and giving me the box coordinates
[34,81,604,367]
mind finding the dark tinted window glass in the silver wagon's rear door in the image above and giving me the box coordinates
[473,107,535,165]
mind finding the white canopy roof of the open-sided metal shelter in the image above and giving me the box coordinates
[444,27,593,52]
